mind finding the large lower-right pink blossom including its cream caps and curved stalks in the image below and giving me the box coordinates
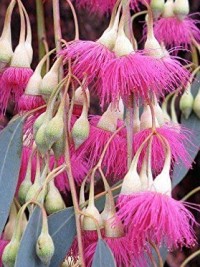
[118,136,197,254]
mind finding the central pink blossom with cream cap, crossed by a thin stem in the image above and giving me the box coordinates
[78,105,126,178]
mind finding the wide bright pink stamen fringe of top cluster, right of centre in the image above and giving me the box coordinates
[100,52,190,105]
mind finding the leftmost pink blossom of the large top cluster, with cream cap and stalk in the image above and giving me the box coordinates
[60,1,121,89]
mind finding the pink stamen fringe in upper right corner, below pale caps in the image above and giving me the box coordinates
[154,16,200,49]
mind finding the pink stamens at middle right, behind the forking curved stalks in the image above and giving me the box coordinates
[134,124,192,174]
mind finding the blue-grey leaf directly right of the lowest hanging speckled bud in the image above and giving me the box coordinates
[48,207,76,267]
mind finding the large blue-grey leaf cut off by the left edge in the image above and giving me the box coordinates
[0,117,24,234]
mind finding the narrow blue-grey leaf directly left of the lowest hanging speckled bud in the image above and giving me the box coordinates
[15,207,45,267]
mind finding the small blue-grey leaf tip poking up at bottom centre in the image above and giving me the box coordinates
[92,239,117,267]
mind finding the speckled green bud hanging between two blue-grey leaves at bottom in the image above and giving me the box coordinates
[36,233,55,266]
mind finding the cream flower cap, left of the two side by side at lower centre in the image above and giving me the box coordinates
[82,204,103,231]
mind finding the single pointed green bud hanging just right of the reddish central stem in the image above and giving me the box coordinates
[72,111,90,149]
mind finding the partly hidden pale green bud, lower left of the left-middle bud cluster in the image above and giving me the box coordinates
[35,123,49,155]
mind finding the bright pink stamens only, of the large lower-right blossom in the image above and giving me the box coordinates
[118,193,197,251]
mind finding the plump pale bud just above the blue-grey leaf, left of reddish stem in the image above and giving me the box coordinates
[44,181,65,214]
